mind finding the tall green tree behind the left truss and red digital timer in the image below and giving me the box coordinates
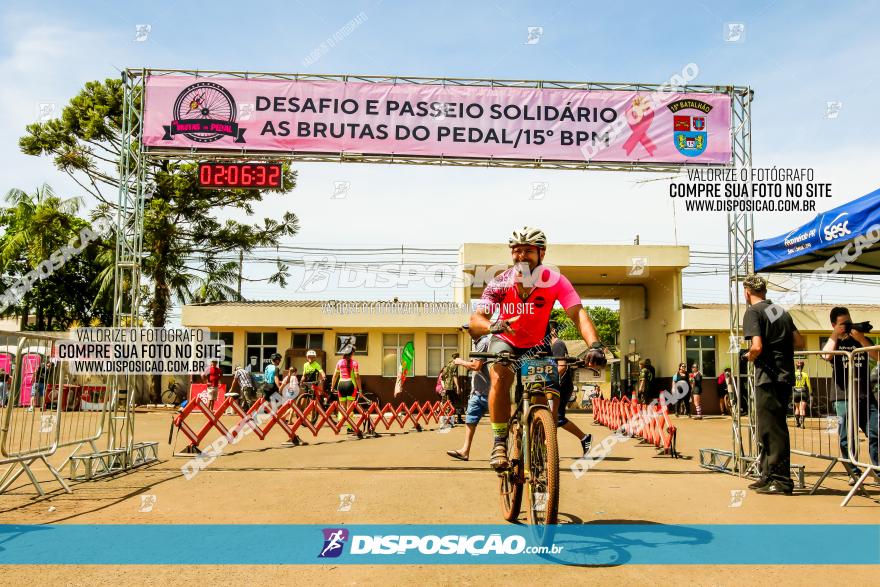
[19,79,299,397]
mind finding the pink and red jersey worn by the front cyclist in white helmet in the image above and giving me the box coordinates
[480,265,581,348]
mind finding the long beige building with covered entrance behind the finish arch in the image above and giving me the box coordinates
[182,243,880,413]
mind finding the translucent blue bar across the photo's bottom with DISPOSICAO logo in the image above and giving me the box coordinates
[0,523,880,566]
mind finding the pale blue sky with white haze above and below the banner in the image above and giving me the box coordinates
[0,0,880,312]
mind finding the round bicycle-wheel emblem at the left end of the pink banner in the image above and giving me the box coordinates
[162,82,246,143]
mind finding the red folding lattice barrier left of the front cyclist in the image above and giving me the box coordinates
[174,396,455,450]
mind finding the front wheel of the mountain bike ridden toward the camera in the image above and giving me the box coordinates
[528,408,559,525]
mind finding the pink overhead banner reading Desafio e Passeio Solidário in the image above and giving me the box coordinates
[143,76,731,164]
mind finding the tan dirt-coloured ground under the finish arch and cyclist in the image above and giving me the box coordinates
[0,410,880,585]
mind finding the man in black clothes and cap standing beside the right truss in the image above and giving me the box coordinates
[743,275,804,494]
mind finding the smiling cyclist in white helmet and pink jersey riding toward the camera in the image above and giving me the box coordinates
[470,227,605,470]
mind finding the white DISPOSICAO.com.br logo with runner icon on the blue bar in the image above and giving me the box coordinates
[319,528,562,558]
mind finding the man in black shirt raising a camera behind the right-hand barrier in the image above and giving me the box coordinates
[822,307,880,485]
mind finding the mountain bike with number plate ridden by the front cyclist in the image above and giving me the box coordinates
[470,351,583,525]
